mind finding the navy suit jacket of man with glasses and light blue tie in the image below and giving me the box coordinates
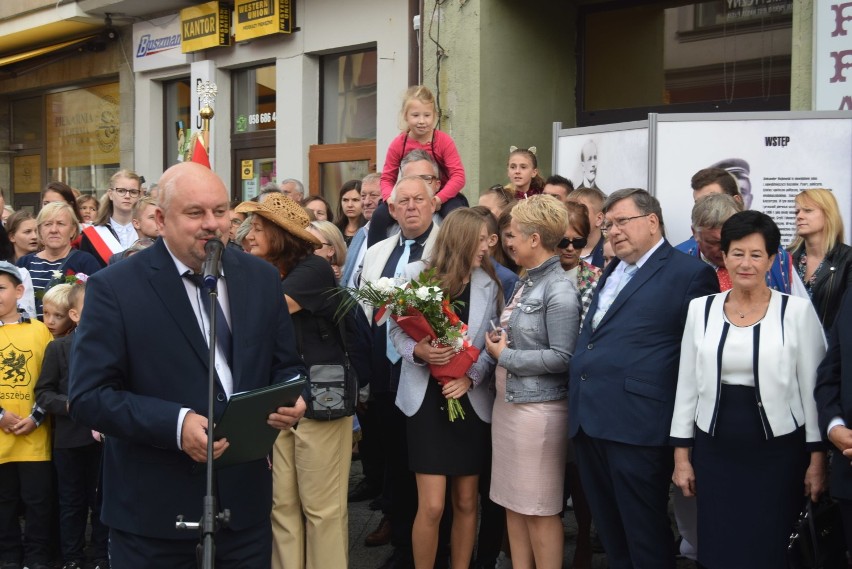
[568,237,719,445]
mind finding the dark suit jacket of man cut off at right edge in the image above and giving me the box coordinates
[814,293,852,500]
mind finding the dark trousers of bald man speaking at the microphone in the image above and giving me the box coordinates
[109,522,272,569]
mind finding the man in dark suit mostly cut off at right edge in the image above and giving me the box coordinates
[814,294,852,550]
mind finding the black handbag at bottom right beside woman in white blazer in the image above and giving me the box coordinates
[787,495,846,569]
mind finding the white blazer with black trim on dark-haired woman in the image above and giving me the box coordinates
[670,290,825,446]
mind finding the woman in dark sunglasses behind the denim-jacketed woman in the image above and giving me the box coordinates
[559,201,601,328]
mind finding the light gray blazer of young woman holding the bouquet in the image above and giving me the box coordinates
[388,261,499,423]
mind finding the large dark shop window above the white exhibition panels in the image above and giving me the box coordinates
[578,0,793,124]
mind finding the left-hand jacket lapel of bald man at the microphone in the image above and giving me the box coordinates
[148,239,208,367]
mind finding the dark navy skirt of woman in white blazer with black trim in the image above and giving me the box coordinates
[692,384,809,569]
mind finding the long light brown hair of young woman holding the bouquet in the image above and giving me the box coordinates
[427,208,503,301]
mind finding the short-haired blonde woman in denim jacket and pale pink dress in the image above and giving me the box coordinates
[486,195,580,569]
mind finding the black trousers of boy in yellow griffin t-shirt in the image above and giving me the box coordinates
[0,460,53,563]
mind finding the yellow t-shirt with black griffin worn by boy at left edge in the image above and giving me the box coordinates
[0,320,53,464]
